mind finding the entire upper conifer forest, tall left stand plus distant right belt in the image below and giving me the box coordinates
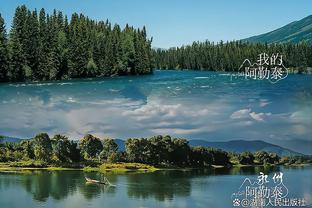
[0,5,312,82]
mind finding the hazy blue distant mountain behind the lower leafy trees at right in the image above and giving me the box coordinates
[189,140,302,156]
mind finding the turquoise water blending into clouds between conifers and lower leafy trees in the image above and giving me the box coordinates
[0,71,312,150]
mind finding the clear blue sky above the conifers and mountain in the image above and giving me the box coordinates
[0,0,312,48]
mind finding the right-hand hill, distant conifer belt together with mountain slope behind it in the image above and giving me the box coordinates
[153,15,312,72]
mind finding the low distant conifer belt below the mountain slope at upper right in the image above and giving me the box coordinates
[153,41,312,71]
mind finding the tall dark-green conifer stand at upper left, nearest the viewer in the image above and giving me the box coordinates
[0,5,152,82]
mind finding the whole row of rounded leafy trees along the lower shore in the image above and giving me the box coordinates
[0,133,311,167]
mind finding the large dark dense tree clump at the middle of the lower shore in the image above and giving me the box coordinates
[126,135,230,167]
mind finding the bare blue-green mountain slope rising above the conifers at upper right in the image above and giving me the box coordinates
[243,15,312,44]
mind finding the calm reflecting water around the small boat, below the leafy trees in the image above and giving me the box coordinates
[0,167,312,208]
